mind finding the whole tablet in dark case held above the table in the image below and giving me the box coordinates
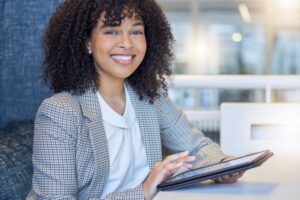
[158,150,273,190]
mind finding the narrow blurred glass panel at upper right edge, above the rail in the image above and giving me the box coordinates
[272,0,300,74]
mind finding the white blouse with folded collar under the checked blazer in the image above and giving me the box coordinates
[97,86,150,198]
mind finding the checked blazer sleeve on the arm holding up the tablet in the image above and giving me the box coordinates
[156,94,227,167]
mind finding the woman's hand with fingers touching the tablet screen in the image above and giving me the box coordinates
[143,151,196,200]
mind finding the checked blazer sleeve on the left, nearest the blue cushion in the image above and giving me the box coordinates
[27,98,144,200]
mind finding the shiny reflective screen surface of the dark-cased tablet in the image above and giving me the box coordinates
[166,151,266,183]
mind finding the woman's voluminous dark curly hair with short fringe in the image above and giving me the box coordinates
[43,0,174,102]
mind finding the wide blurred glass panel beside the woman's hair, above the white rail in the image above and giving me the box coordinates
[164,2,266,74]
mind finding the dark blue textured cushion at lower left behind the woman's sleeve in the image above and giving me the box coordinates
[0,120,34,200]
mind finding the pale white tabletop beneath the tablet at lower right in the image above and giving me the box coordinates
[154,155,300,200]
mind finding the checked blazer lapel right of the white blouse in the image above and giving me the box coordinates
[126,83,162,169]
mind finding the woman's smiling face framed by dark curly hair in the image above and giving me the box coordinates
[87,14,147,83]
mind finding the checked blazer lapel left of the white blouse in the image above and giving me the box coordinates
[78,89,109,196]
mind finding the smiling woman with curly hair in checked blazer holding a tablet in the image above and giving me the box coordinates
[27,0,241,199]
